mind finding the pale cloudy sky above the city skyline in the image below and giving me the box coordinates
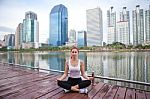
[0,0,150,43]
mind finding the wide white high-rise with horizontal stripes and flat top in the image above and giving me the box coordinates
[86,8,103,46]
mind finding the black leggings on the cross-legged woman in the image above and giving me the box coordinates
[58,77,91,90]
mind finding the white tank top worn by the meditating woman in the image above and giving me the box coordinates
[68,59,80,78]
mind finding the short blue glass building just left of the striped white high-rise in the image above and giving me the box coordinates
[77,31,87,47]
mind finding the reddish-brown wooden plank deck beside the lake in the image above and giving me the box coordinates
[0,64,150,99]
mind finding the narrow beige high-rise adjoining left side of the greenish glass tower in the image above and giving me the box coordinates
[15,23,23,49]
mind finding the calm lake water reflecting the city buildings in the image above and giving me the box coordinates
[0,52,150,90]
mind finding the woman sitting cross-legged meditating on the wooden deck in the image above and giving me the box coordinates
[57,47,93,93]
